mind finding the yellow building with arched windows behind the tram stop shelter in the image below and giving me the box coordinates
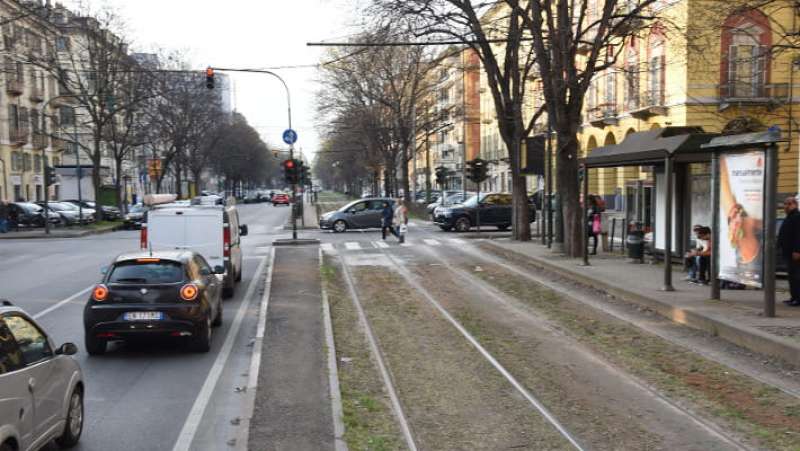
[579,0,800,217]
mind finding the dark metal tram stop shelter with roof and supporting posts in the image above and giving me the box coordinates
[582,127,719,291]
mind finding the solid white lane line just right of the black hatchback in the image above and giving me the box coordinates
[172,258,267,451]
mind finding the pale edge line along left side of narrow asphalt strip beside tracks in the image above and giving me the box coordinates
[236,247,276,450]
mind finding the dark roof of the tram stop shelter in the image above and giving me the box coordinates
[583,127,719,168]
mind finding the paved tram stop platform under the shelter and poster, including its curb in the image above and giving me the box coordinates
[487,240,800,365]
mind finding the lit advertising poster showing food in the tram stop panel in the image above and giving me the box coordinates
[718,151,765,288]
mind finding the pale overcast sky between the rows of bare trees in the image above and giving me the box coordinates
[63,0,358,162]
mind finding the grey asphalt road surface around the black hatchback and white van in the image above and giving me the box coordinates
[0,204,289,451]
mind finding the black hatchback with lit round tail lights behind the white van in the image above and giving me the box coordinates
[83,251,225,355]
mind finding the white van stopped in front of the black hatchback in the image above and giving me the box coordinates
[140,201,247,298]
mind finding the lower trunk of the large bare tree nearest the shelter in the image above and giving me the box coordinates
[556,132,586,257]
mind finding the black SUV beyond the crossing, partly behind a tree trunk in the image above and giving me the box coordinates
[433,193,536,232]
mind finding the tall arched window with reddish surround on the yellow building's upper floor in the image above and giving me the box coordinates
[720,10,772,98]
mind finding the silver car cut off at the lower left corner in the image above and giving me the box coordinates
[0,301,84,451]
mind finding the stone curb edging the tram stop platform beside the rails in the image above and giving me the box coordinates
[485,240,800,366]
